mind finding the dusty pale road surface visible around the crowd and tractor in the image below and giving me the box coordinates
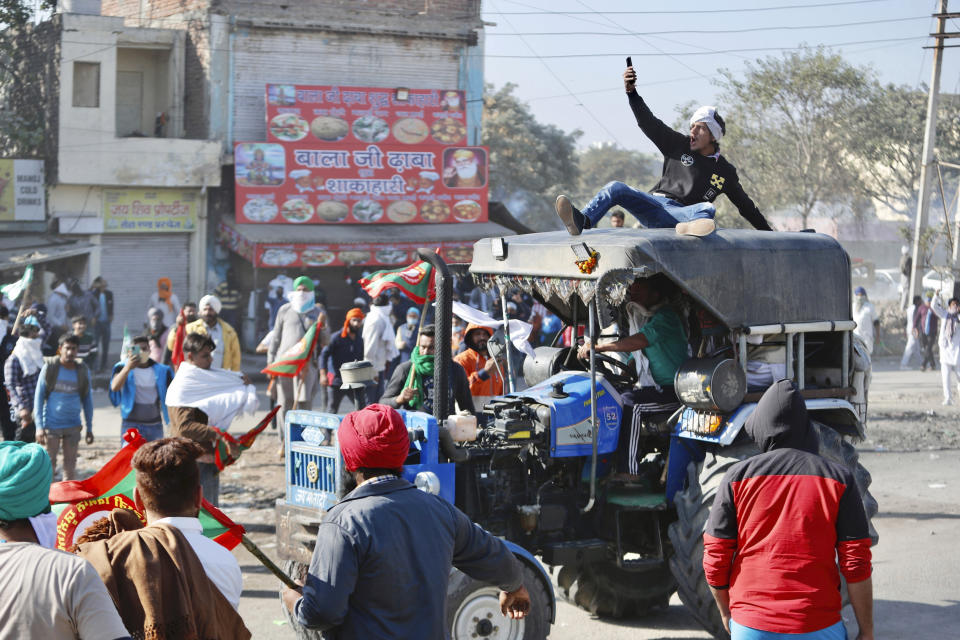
[80,352,960,640]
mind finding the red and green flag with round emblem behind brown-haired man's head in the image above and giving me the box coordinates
[50,429,244,551]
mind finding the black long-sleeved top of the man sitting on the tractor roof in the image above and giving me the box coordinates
[627,91,770,231]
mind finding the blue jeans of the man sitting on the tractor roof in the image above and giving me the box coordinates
[581,182,717,229]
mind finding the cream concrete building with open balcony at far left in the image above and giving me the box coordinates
[7,2,221,356]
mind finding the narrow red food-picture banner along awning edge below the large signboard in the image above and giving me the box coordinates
[255,242,473,267]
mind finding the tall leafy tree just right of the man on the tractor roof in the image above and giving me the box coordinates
[718,48,873,227]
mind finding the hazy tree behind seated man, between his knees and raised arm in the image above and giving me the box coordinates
[571,143,660,222]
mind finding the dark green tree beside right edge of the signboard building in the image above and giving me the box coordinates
[483,83,581,229]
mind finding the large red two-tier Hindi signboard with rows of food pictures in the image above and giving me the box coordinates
[234,85,489,224]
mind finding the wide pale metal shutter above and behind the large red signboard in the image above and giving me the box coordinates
[233,30,463,142]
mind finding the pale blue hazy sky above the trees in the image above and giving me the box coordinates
[483,0,960,152]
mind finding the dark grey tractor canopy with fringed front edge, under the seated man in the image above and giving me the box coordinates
[470,228,851,329]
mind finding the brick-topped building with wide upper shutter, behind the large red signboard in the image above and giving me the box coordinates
[101,0,512,346]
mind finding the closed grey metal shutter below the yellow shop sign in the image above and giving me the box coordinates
[100,233,190,354]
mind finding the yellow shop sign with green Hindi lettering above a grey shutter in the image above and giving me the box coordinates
[103,189,200,233]
